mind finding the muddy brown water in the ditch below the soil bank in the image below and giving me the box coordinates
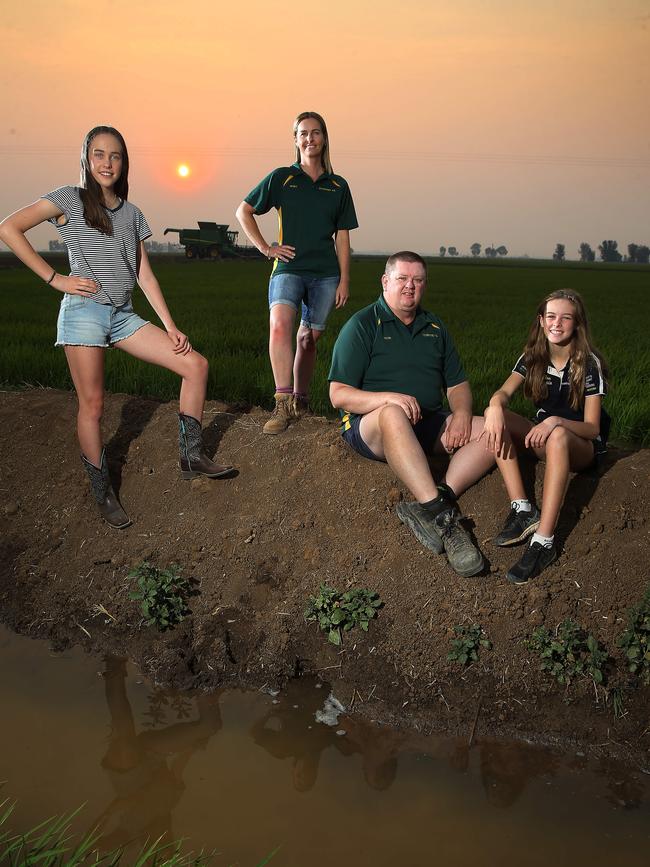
[0,627,650,867]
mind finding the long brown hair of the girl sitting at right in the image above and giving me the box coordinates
[524,289,608,410]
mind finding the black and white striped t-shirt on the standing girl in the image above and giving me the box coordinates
[41,187,151,307]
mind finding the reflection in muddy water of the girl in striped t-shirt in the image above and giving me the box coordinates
[91,656,222,850]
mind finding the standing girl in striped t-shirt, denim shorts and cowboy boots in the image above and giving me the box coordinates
[0,126,231,528]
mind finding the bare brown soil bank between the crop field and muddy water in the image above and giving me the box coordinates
[0,389,650,768]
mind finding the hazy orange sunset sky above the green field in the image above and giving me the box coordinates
[0,0,650,258]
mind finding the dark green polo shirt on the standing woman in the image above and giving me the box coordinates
[246,163,359,277]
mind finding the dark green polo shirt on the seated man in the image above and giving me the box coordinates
[328,295,467,430]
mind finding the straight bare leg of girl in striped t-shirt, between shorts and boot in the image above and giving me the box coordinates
[65,346,106,467]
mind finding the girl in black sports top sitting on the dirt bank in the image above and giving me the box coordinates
[481,289,609,584]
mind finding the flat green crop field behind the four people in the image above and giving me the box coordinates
[0,256,650,446]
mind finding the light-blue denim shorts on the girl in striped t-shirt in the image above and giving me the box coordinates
[54,293,148,347]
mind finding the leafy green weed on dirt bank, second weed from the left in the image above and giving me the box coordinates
[305,584,384,646]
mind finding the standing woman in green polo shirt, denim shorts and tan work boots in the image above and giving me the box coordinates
[237,111,359,434]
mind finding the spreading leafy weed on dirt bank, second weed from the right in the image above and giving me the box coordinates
[526,618,609,684]
